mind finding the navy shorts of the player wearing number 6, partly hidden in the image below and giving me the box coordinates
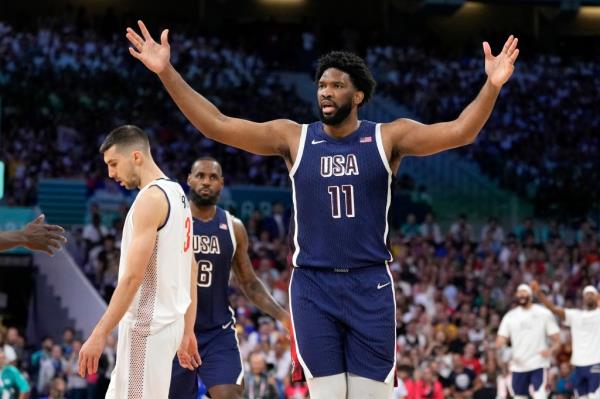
[169,323,244,399]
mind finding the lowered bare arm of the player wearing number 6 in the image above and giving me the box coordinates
[232,218,290,328]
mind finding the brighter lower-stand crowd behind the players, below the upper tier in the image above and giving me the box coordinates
[0,205,600,399]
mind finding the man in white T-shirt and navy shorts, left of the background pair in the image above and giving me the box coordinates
[496,284,560,399]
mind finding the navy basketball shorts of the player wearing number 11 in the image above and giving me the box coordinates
[290,265,396,383]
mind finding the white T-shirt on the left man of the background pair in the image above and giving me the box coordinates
[498,304,559,372]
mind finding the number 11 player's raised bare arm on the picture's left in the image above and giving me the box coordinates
[127,21,300,156]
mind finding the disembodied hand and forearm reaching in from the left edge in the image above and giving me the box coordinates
[0,215,67,255]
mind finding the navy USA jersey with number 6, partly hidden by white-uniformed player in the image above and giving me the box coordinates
[193,207,236,332]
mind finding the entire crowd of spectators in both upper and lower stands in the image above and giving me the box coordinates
[0,12,600,399]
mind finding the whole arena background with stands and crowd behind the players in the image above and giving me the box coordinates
[0,0,600,398]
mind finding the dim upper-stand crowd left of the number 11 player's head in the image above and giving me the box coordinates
[0,21,313,209]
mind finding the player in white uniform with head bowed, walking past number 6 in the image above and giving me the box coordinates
[79,125,199,399]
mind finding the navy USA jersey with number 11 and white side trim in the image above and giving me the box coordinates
[290,121,392,269]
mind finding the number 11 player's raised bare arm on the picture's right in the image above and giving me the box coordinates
[381,35,519,156]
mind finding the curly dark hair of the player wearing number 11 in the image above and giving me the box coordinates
[315,51,377,107]
